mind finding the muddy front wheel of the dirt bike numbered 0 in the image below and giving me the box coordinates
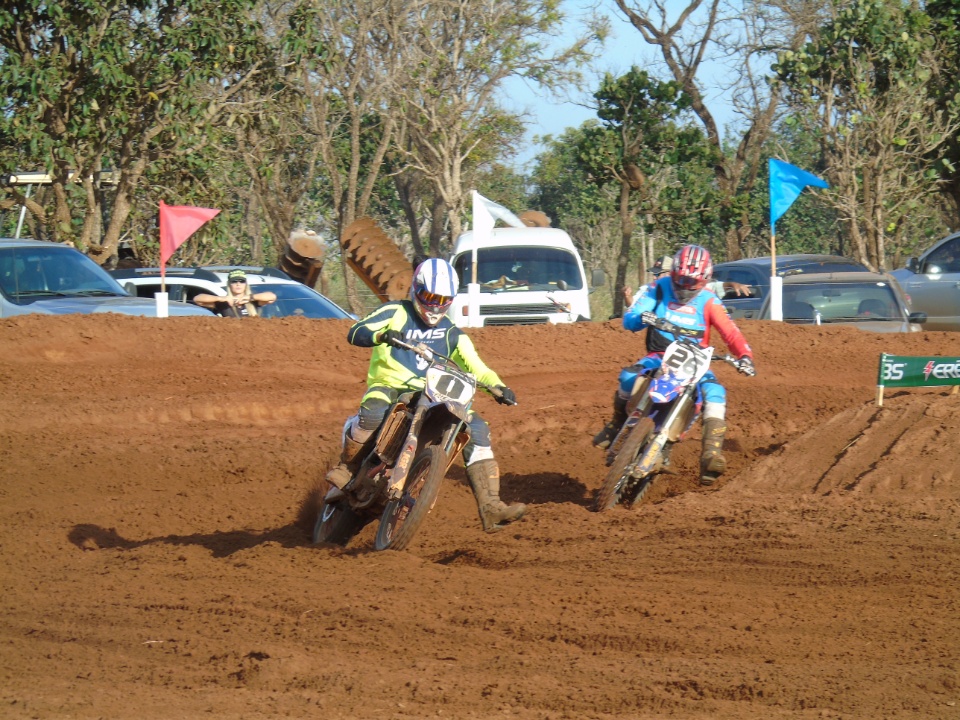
[375,445,447,550]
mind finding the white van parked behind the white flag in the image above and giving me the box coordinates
[450,227,603,327]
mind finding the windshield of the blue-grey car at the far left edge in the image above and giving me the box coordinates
[0,244,126,304]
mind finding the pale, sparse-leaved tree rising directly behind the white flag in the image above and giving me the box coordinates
[397,0,606,252]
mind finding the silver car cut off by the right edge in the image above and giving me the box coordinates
[890,233,960,331]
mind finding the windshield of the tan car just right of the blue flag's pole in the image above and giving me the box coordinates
[783,281,905,323]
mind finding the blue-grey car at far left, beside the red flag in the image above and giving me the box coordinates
[0,238,213,317]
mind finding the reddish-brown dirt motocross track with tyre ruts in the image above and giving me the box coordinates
[0,316,960,720]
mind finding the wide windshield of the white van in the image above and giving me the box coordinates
[453,246,583,292]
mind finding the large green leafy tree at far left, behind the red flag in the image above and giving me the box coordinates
[0,0,264,262]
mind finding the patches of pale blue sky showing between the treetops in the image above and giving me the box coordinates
[505,0,735,169]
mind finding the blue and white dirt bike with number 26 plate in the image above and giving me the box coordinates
[596,313,755,512]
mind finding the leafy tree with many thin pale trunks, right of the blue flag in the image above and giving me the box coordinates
[774,0,958,269]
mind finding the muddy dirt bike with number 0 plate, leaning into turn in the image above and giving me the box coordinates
[313,341,510,550]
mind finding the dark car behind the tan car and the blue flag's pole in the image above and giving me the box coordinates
[713,254,870,318]
